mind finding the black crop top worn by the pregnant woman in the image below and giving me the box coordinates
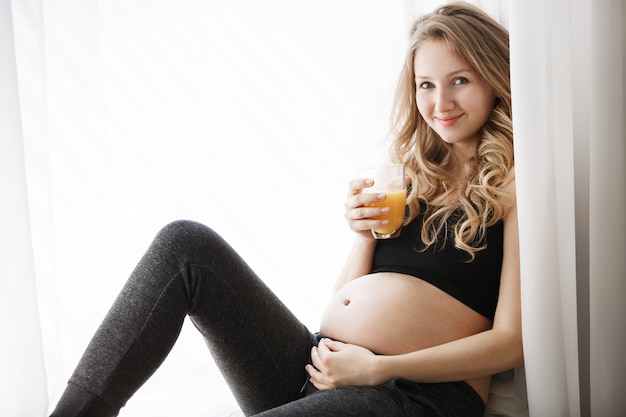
[372,205,504,320]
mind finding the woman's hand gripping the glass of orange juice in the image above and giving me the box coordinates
[345,178,389,240]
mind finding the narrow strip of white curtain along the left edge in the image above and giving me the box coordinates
[0,1,47,416]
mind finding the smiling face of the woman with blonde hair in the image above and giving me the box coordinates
[414,41,495,156]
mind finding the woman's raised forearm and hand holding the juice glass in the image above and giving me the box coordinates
[335,179,389,292]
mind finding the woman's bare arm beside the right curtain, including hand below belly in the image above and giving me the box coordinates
[309,179,524,388]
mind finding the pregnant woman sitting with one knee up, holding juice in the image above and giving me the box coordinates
[52,4,523,417]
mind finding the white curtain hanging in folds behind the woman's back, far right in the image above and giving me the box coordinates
[510,0,626,417]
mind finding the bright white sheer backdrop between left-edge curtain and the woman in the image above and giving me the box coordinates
[8,0,413,416]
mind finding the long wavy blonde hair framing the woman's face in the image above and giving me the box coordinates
[390,3,514,260]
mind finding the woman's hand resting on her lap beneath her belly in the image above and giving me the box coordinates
[306,339,378,390]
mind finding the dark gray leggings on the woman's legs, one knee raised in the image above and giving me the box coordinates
[52,221,484,417]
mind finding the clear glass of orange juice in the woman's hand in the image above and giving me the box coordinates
[358,164,406,239]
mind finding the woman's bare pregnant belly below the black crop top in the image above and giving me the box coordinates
[320,273,491,400]
